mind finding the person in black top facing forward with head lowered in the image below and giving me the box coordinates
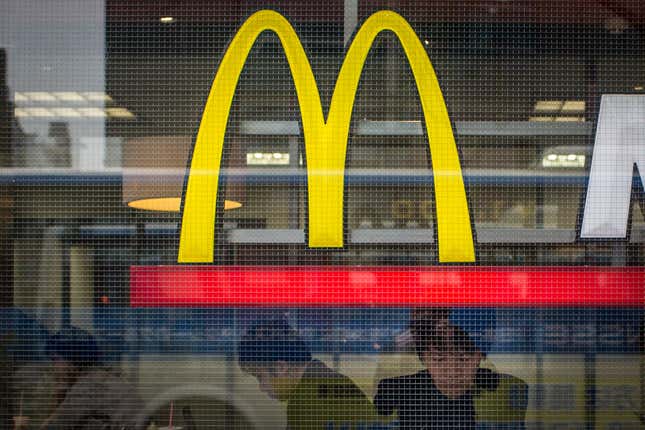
[374,318,499,429]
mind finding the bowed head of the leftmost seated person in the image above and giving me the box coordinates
[47,327,101,382]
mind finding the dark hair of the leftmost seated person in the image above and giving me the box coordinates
[46,327,101,370]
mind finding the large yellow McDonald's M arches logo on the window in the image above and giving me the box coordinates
[178,10,475,263]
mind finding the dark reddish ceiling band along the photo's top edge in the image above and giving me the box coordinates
[107,0,645,26]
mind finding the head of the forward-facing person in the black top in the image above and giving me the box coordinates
[417,324,484,397]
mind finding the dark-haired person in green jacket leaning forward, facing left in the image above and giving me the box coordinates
[239,320,384,430]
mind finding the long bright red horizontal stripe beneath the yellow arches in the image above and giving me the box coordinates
[130,266,645,307]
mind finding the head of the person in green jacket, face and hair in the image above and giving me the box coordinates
[239,320,311,400]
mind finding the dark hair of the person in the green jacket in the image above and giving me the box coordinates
[238,319,311,369]
